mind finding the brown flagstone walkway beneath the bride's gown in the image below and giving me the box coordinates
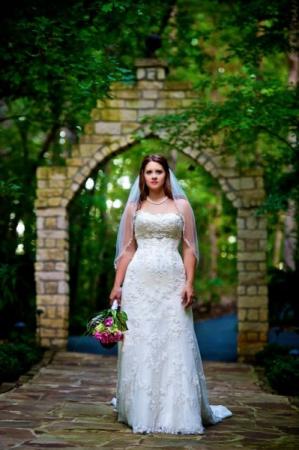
[0,352,299,450]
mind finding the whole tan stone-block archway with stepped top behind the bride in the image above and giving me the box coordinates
[35,59,268,360]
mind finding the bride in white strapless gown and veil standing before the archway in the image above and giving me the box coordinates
[110,155,232,434]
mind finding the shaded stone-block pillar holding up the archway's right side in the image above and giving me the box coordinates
[237,208,268,361]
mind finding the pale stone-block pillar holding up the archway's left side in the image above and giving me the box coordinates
[35,167,69,347]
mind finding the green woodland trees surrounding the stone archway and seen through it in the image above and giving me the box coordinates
[0,0,299,338]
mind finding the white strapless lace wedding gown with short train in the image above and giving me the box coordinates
[116,210,232,434]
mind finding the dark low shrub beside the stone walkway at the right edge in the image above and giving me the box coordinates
[256,344,299,395]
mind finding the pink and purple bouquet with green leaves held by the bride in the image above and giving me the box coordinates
[87,300,128,348]
